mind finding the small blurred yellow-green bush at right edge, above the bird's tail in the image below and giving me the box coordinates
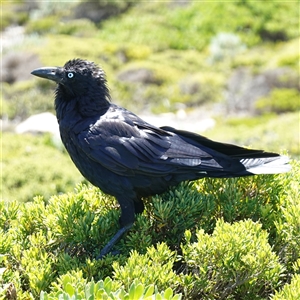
[255,88,300,113]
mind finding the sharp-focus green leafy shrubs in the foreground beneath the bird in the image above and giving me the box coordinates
[0,161,300,299]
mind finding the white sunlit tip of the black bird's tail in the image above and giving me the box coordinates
[240,156,291,174]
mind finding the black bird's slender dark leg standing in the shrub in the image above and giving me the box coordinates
[97,196,135,259]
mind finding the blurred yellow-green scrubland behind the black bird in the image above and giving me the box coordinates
[0,0,300,201]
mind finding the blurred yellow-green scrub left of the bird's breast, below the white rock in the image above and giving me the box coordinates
[0,133,82,201]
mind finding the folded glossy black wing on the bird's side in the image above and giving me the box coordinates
[75,117,218,176]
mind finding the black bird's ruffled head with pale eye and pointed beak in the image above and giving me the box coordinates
[31,59,109,100]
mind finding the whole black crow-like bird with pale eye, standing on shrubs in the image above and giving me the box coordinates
[31,59,290,257]
